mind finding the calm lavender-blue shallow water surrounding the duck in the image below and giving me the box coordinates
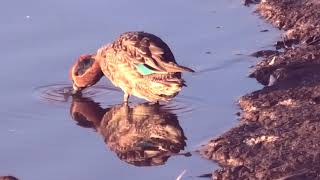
[0,0,277,180]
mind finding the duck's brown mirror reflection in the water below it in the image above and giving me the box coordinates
[70,95,191,166]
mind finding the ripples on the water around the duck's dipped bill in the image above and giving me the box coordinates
[34,84,119,103]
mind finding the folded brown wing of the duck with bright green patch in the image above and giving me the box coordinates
[112,32,194,74]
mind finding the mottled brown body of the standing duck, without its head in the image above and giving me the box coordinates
[71,32,194,102]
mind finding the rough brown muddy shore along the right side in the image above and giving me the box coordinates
[199,0,320,180]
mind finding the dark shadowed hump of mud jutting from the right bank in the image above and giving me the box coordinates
[250,43,320,85]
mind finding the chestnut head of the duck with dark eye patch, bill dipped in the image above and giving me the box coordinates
[70,54,103,93]
